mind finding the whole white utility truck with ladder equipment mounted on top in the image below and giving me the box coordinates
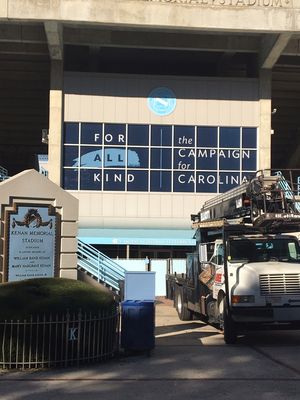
[166,171,300,344]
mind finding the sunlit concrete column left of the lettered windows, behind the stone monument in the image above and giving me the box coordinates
[48,60,63,186]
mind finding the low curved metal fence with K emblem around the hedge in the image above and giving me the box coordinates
[0,306,120,369]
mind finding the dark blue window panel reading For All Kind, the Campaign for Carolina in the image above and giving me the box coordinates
[63,122,257,193]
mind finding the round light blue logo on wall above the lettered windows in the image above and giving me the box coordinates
[148,87,176,116]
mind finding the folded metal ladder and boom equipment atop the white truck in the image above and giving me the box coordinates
[191,170,300,232]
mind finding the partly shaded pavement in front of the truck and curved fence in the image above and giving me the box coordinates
[0,299,300,400]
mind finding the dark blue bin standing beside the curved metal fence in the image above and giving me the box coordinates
[121,300,155,351]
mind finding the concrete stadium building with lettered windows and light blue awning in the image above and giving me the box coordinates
[0,0,300,258]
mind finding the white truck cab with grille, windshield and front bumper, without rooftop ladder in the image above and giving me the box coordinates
[199,234,300,342]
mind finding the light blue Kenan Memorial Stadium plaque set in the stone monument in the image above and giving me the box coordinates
[7,205,57,282]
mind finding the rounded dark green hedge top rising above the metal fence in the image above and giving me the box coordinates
[0,278,115,321]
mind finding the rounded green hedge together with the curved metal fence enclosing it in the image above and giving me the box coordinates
[0,278,118,368]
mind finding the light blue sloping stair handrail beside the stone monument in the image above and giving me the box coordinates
[77,239,126,292]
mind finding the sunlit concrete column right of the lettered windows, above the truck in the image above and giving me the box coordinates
[258,69,272,169]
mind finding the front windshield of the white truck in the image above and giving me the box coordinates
[228,238,300,262]
